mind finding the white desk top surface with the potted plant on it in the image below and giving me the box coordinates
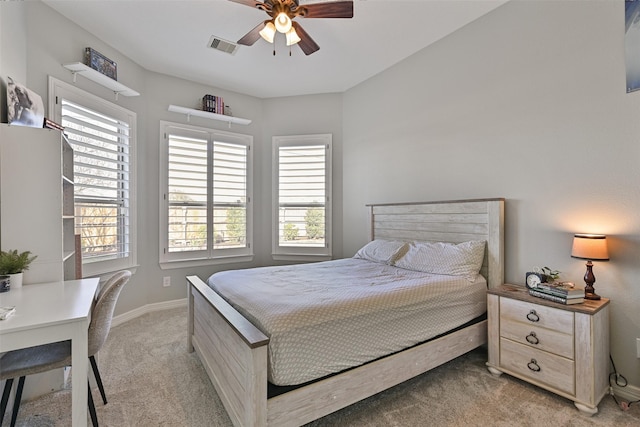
[0,278,100,335]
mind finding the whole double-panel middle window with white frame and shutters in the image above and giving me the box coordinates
[160,122,253,267]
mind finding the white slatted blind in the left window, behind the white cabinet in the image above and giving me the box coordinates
[61,98,131,262]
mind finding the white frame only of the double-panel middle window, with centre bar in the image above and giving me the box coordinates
[159,120,254,269]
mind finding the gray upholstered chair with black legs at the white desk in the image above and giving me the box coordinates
[0,270,131,427]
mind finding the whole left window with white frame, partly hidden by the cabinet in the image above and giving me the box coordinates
[49,78,136,276]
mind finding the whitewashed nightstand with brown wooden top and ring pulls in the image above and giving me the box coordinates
[487,285,609,415]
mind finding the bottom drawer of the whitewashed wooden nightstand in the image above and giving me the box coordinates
[500,338,575,395]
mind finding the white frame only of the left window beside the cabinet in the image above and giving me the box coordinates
[48,76,138,277]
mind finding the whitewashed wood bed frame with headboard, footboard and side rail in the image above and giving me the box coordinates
[187,199,504,427]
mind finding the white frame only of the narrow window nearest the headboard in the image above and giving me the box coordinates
[272,133,333,261]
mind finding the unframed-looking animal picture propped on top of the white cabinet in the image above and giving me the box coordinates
[7,77,44,128]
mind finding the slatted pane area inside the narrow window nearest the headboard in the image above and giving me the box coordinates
[278,145,326,247]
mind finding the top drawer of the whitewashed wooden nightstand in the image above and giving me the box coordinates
[500,298,573,336]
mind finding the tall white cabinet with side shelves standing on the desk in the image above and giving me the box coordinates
[0,124,76,284]
